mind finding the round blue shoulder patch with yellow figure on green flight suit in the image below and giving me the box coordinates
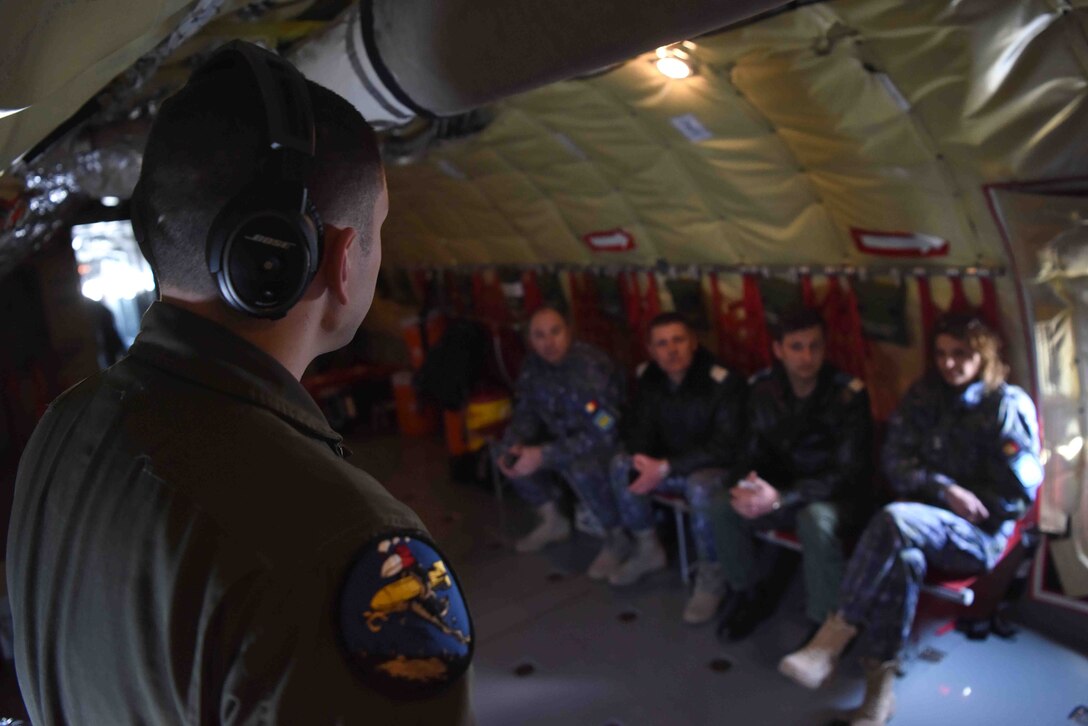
[338,533,473,698]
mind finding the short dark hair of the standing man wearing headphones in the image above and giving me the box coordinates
[133,69,384,294]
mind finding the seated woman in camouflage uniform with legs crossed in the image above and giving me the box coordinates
[779,316,1042,724]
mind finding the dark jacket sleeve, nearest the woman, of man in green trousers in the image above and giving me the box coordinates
[781,379,873,506]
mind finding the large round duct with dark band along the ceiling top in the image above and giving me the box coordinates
[290,0,789,127]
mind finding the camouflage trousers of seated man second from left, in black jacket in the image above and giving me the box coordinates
[611,454,726,562]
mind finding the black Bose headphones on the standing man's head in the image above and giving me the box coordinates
[198,40,324,319]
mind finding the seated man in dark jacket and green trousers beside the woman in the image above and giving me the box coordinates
[713,308,871,640]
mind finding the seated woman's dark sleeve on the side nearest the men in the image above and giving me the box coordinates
[880,383,956,506]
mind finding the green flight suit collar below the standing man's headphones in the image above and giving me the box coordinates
[129,302,344,448]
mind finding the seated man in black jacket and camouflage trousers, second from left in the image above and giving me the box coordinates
[609,312,745,624]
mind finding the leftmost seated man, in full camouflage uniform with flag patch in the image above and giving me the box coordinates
[498,306,623,579]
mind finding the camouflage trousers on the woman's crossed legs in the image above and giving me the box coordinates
[839,502,1007,661]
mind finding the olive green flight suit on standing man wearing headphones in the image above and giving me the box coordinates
[7,303,473,726]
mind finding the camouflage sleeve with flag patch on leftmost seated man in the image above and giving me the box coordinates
[541,354,622,469]
